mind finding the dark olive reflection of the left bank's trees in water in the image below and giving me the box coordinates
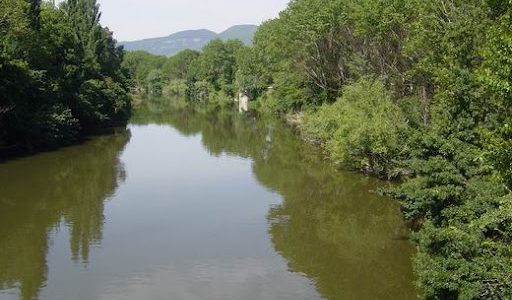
[0,130,129,299]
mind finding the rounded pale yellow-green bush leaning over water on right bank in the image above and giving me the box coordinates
[302,79,408,178]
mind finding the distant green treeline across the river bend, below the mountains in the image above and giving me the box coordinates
[123,39,249,107]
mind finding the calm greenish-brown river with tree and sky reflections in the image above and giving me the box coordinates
[0,100,416,300]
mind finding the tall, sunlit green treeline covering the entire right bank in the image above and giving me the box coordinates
[133,0,512,299]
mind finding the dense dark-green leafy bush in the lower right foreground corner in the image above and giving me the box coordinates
[388,127,512,299]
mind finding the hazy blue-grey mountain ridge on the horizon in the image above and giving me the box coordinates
[119,25,258,56]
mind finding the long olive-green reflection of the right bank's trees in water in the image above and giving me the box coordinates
[162,103,415,299]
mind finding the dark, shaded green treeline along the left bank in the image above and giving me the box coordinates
[0,0,131,153]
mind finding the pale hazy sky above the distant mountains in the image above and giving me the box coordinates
[90,0,288,41]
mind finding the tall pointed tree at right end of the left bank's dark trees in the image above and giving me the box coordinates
[62,0,130,130]
